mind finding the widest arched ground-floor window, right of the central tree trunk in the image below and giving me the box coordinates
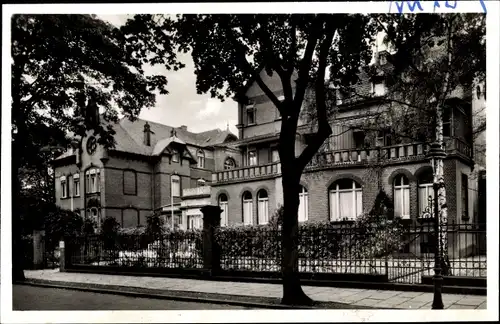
[330,179,363,221]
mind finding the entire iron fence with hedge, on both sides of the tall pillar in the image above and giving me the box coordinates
[66,219,486,284]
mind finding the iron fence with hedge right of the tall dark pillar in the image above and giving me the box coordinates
[216,221,486,284]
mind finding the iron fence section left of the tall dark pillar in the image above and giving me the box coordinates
[67,232,203,269]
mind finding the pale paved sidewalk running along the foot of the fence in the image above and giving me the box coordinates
[24,269,486,309]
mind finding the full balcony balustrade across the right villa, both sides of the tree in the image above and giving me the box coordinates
[212,138,472,183]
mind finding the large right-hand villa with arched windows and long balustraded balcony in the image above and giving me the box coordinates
[211,52,478,228]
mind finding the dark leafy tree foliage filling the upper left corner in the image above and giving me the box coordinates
[10,14,183,279]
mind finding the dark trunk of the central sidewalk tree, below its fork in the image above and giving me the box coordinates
[281,168,313,305]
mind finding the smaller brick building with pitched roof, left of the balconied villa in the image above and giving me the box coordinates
[53,118,236,228]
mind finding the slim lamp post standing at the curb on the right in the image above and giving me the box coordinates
[427,143,446,309]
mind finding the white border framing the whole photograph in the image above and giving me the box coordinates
[1,1,500,323]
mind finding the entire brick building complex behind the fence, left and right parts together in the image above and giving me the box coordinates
[55,52,485,235]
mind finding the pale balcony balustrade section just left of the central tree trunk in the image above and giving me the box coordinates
[212,162,281,183]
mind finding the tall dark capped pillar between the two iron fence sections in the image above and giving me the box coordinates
[200,205,222,275]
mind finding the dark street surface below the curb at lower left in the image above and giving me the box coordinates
[12,285,249,310]
